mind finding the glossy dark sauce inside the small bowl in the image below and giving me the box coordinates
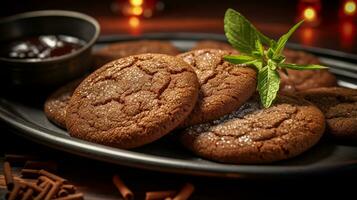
[0,35,85,60]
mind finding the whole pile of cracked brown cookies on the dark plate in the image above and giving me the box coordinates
[45,41,357,164]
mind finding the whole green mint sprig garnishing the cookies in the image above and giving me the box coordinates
[224,9,327,108]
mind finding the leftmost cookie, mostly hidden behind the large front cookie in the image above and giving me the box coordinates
[44,79,83,128]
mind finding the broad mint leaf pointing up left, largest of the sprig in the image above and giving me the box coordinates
[224,8,274,54]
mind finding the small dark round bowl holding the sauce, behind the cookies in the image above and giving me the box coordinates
[0,10,100,88]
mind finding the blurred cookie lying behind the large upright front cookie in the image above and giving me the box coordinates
[93,40,179,68]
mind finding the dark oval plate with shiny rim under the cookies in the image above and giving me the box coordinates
[0,33,357,178]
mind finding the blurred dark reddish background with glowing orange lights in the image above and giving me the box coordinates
[0,0,357,54]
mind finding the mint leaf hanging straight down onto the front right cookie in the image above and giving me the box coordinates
[258,66,280,108]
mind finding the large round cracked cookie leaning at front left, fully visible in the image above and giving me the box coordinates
[66,54,199,149]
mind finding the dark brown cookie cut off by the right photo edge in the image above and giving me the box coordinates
[298,87,357,140]
